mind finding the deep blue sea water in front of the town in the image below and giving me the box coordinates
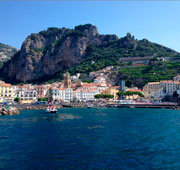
[0,108,180,170]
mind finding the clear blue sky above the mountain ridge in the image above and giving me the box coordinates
[0,0,180,52]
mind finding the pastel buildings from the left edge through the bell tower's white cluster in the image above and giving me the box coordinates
[0,73,110,103]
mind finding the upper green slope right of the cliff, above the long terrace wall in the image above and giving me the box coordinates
[69,36,178,74]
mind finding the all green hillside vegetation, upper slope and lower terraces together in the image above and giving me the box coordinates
[40,37,180,87]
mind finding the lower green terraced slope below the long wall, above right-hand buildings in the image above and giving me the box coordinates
[119,62,180,87]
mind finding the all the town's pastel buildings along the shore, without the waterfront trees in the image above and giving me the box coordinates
[0,67,180,103]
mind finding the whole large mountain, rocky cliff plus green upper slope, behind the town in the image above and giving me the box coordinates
[1,24,179,82]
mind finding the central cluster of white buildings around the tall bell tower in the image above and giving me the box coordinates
[48,73,110,102]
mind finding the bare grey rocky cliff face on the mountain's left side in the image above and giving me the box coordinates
[2,24,118,82]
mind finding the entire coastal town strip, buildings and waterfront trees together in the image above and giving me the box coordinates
[0,66,180,106]
